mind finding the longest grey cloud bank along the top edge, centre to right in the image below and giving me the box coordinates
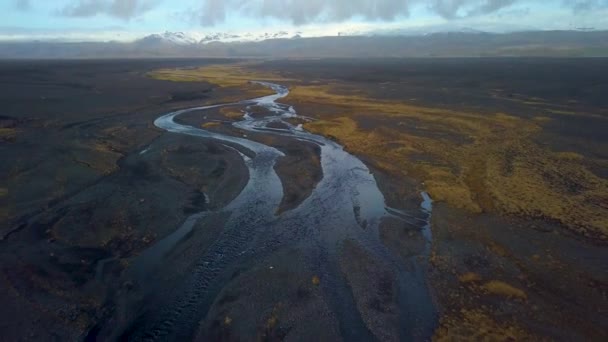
[190,0,520,26]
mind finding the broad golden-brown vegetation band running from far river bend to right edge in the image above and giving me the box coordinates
[151,64,608,239]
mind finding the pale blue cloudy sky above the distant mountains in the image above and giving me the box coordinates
[0,0,608,40]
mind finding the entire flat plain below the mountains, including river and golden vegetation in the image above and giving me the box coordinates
[0,58,608,341]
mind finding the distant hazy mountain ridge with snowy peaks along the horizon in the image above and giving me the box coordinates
[0,29,608,59]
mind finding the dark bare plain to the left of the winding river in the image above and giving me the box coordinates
[0,60,252,340]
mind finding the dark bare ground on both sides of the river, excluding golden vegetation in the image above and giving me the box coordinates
[0,59,608,341]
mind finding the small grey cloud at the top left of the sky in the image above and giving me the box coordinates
[59,0,157,20]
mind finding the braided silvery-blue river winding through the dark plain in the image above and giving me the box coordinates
[116,82,436,341]
